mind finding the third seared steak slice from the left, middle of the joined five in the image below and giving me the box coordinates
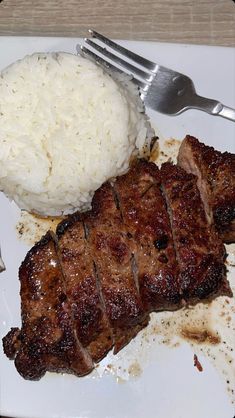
[84,183,147,352]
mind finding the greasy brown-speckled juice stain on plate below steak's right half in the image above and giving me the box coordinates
[92,289,235,403]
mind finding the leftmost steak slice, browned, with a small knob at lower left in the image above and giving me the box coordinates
[3,232,93,380]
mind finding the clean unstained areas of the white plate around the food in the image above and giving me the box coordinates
[0,37,235,418]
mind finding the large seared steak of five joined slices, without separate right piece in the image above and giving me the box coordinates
[3,149,231,379]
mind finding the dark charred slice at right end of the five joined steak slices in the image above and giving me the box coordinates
[161,163,231,302]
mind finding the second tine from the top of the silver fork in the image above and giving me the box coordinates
[85,38,153,82]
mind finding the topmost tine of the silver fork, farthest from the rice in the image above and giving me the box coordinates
[88,29,158,72]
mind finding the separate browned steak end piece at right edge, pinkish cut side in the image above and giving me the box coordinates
[178,135,235,242]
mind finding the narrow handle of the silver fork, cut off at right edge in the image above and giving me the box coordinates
[192,95,235,122]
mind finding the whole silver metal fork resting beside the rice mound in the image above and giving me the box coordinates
[80,29,235,122]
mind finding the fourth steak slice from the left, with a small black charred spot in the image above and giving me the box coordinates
[114,160,181,312]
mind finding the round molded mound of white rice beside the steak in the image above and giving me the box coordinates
[0,53,150,216]
